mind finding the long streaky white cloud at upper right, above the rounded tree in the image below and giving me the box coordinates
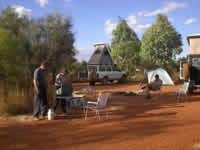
[141,2,187,17]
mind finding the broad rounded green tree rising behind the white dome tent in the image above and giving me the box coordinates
[141,14,182,69]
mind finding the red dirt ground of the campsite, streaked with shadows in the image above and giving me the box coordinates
[0,83,200,150]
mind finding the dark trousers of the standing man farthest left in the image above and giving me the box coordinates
[33,89,48,117]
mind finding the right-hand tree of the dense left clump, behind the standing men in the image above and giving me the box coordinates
[38,12,76,83]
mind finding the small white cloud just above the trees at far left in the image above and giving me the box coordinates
[12,5,32,17]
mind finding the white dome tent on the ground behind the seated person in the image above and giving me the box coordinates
[147,68,174,85]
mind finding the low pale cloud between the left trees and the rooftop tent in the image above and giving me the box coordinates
[75,48,94,61]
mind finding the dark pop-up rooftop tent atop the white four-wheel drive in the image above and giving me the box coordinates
[88,44,113,65]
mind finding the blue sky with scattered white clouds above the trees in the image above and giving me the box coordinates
[0,0,200,61]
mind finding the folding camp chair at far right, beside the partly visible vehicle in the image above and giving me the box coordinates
[174,82,189,100]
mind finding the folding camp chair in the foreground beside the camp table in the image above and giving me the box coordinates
[85,92,110,120]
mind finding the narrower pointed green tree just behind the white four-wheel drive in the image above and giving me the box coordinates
[111,17,141,74]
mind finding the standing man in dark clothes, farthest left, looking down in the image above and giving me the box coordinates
[33,61,48,120]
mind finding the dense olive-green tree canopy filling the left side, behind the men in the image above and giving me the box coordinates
[0,7,76,86]
